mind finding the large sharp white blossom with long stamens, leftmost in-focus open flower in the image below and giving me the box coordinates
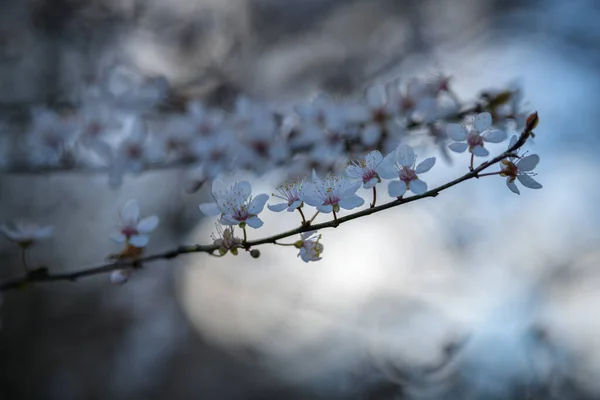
[199,179,269,229]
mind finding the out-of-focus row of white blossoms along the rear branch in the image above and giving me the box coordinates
[0,67,522,190]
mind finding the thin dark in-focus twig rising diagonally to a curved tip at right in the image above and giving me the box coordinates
[0,122,537,291]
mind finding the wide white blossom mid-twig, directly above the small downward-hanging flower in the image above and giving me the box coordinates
[304,171,365,214]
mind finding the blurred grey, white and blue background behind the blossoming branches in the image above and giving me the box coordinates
[0,0,600,399]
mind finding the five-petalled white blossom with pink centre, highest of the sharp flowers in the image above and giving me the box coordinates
[447,112,506,157]
